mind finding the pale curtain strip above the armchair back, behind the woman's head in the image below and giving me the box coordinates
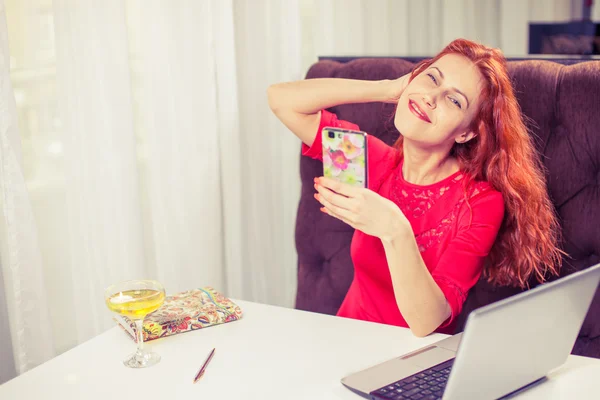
[300,0,600,70]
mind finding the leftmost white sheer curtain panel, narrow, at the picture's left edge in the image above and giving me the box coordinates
[0,3,54,382]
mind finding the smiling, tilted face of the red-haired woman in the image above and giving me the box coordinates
[394,54,483,151]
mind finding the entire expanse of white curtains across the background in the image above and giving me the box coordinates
[0,0,600,382]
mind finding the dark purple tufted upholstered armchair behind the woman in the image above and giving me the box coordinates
[296,54,600,358]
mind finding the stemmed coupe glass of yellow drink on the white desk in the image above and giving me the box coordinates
[104,280,165,368]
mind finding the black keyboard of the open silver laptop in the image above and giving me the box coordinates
[370,359,454,400]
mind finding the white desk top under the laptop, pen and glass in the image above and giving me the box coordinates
[0,301,600,400]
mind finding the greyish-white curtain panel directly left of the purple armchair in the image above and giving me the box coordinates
[232,0,305,306]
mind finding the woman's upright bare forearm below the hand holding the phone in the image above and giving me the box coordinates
[382,227,451,337]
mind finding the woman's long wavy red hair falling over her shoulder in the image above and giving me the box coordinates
[396,39,565,288]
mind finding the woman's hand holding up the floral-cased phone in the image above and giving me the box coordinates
[315,177,412,242]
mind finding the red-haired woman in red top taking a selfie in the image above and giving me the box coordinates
[268,39,561,336]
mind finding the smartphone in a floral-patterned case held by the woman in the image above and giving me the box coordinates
[321,127,368,188]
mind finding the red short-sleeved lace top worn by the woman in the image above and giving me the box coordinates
[302,111,504,333]
